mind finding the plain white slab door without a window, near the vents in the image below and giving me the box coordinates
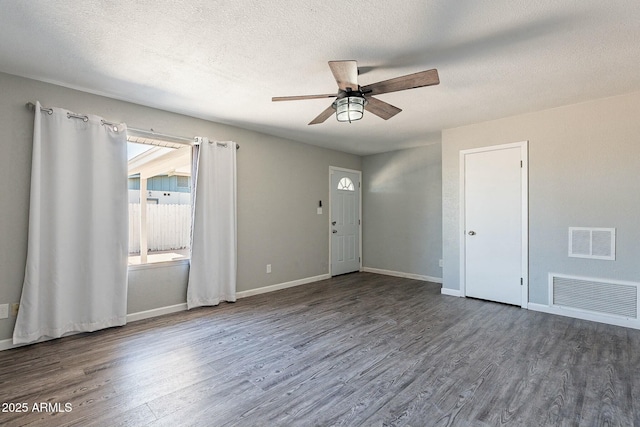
[461,142,527,307]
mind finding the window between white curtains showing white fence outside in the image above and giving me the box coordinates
[128,138,191,265]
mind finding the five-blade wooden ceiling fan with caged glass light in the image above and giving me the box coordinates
[271,61,440,125]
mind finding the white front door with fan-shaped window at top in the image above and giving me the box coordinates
[330,168,360,276]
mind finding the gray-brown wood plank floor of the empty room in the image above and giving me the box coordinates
[0,273,640,427]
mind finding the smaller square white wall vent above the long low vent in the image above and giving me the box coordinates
[569,227,616,260]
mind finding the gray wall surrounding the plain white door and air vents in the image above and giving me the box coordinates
[442,93,640,304]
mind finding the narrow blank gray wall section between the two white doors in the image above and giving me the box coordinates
[362,144,442,278]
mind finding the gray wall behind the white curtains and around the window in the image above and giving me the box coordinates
[0,73,361,340]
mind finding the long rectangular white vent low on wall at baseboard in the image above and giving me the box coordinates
[549,273,638,319]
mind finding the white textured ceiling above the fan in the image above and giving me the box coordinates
[0,0,640,154]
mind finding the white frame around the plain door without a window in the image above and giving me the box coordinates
[459,141,529,308]
